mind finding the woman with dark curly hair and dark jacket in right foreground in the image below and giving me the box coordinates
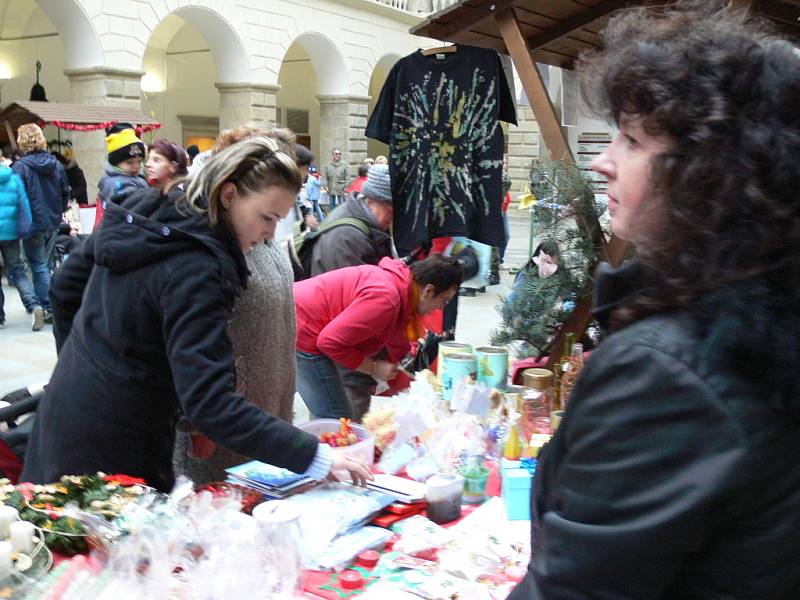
[509,0,800,600]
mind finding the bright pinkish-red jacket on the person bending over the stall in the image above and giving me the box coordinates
[294,258,413,369]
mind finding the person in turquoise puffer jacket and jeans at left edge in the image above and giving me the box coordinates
[0,165,32,327]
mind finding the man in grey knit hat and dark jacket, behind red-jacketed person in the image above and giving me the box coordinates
[304,165,395,420]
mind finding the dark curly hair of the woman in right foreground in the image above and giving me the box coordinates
[578,0,800,328]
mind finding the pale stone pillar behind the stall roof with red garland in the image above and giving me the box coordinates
[64,67,144,202]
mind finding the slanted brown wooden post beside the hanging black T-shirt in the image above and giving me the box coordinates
[495,7,573,160]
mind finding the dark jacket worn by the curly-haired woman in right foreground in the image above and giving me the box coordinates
[509,264,800,600]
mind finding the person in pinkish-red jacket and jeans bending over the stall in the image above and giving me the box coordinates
[294,254,461,419]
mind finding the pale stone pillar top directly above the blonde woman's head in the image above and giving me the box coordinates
[214,83,280,131]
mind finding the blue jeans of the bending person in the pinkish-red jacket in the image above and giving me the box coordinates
[296,350,353,419]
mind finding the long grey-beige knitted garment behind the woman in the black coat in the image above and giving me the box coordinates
[173,242,297,483]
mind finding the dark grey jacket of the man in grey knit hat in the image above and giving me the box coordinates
[311,194,392,277]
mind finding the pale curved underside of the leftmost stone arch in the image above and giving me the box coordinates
[36,0,104,69]
